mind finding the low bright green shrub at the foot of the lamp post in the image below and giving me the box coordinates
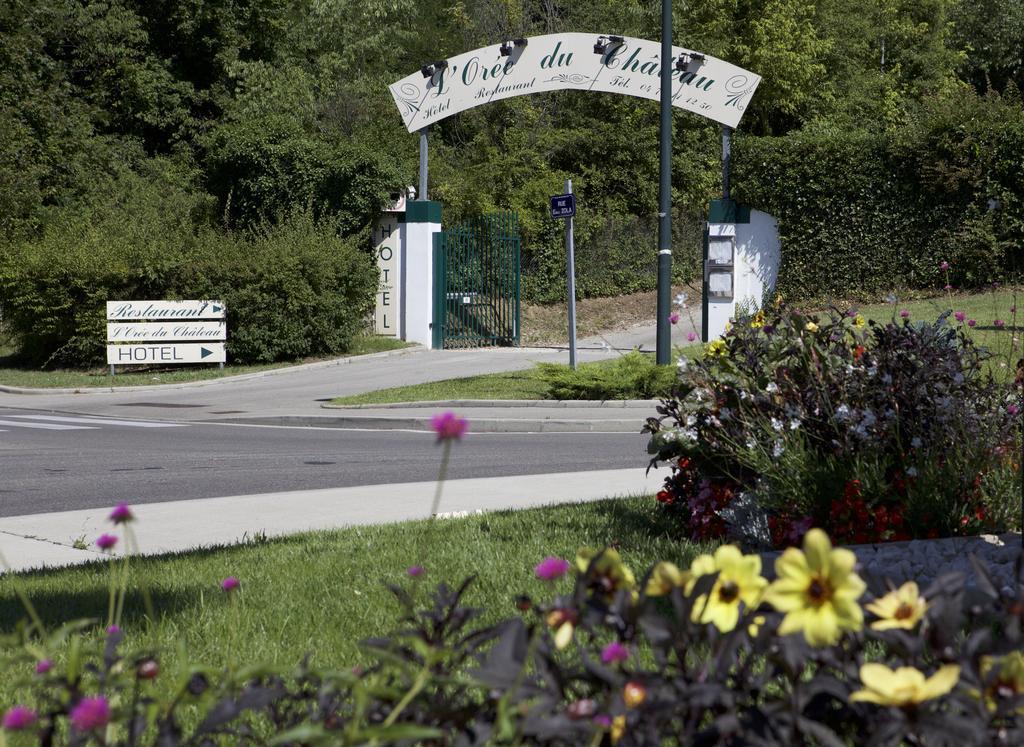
[538,350,675,401]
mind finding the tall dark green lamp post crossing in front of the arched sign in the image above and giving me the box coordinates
[655,0,672,366]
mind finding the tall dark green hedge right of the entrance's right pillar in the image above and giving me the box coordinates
[734,93,1024,298]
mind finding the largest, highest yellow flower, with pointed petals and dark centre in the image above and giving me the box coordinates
[766,529,865,646]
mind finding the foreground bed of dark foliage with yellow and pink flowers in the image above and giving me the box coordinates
[2,531,1024,747]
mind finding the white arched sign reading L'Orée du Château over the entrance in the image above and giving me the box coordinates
[390,34,761,132]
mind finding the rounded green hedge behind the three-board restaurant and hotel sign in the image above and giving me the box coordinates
[0,172,377,368]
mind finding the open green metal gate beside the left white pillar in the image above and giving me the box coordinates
[433,212,519,348]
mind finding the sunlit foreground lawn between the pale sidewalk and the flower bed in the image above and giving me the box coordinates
[0,496,710,703]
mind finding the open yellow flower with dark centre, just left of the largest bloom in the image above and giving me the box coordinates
[686,545,768,633]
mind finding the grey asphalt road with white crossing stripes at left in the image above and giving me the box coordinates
[0,409,647,516]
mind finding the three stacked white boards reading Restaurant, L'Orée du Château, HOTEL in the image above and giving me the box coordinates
[106,300,227,372]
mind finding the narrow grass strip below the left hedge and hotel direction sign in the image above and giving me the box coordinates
[0,336,409,388]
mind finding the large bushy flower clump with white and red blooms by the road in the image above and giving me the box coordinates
[647,306,1020,544]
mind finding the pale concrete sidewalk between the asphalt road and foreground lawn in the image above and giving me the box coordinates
[0,466,666,571]
